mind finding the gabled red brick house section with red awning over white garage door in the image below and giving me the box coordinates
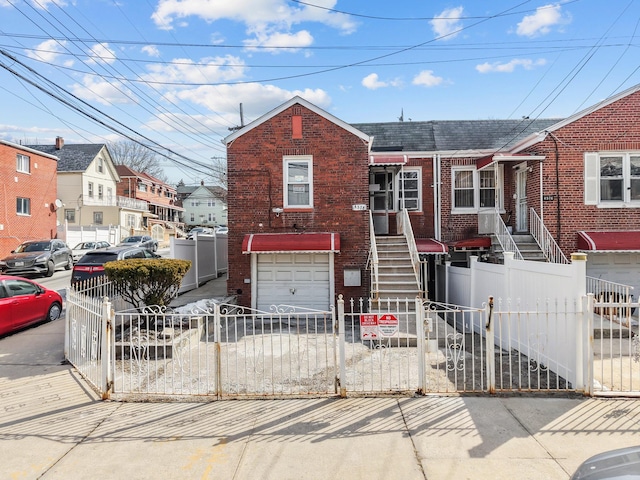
[225,97,370,310]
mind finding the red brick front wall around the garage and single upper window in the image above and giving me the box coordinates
[227,105,369,305]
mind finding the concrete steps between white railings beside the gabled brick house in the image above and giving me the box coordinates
[376,236,420,299]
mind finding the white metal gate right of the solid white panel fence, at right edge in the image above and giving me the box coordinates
[586,295,640,396]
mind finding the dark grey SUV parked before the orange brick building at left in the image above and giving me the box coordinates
[0,239,73,277]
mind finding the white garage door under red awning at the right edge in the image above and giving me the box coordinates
[587,252,640,300]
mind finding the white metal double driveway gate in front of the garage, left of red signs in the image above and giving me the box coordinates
[108,304,337,398]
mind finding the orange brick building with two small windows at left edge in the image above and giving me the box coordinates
[0,140,60,258]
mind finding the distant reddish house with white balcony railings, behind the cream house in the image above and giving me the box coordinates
[116,165,184,227]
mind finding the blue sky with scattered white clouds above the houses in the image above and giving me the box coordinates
[0,0,640,183]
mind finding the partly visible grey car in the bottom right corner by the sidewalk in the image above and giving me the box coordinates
[571,447,640,480]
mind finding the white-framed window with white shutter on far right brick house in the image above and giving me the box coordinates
[584,152,640,207]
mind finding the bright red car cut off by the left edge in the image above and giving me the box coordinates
[0,275,62,335]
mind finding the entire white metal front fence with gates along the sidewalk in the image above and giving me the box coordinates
[65,291,640,399]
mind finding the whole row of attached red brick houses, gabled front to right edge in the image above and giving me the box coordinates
[226,86,640,308]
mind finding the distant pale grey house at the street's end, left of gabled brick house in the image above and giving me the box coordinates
[178,182,227,228]
